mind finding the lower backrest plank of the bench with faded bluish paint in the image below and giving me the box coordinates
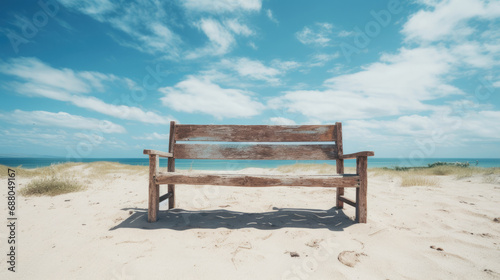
[174,144,337,160]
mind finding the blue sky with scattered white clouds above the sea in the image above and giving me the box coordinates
[0,0,500,159]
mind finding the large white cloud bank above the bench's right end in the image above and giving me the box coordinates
[268,48,462,121]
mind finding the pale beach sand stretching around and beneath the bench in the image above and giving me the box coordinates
[0,165,500,279]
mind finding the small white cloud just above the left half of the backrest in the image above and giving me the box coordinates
[160,76,264,119]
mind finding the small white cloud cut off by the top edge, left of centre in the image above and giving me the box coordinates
[182,0,262,13]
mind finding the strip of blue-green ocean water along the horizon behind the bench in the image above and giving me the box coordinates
[0,157,500,170]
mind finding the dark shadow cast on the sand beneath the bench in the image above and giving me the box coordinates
[110,207,354,231]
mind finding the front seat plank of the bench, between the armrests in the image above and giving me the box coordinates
[156,172,359,187]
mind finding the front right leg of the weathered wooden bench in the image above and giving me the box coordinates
[356,156,368,223]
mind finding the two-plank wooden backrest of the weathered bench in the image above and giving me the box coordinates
[169,122,343,160]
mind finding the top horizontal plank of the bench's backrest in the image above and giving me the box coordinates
[175,124,336,142]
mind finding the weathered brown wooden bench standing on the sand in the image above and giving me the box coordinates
[144,122,374,223]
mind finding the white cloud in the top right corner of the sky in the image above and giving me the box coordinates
[402,0,500,42]
